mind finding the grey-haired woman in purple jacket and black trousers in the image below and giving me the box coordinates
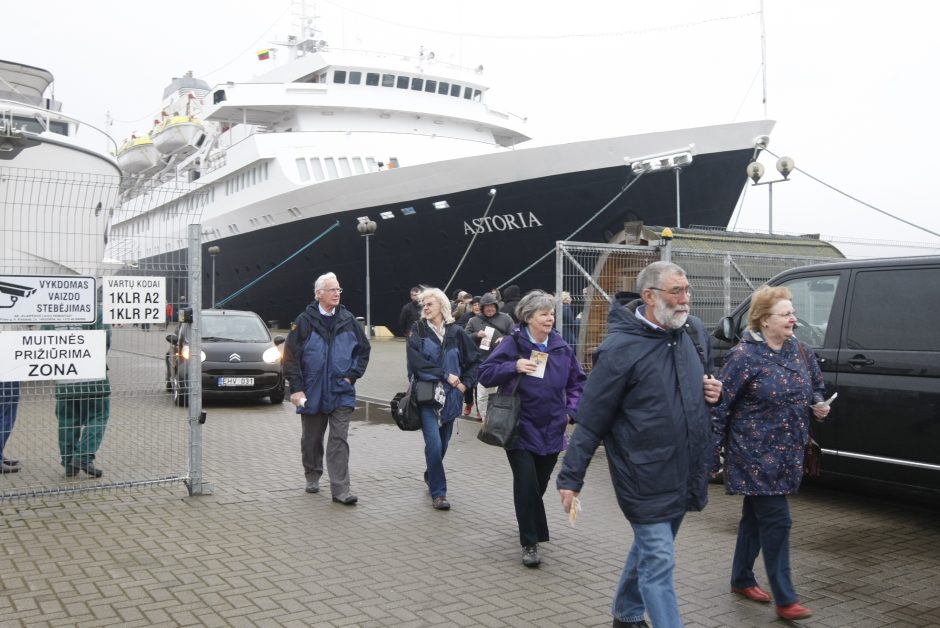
[480,290,585,567]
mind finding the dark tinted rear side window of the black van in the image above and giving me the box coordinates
[846,268,940,351]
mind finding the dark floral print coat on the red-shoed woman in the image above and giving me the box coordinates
[712,331,825,495]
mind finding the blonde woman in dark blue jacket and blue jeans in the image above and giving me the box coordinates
[407,288,480,510]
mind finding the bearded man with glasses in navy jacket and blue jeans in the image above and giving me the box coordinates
[557,262,721,628]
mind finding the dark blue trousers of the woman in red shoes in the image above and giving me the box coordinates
[731,495,799,606]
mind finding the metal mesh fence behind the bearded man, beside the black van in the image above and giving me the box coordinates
[555,240,837,371]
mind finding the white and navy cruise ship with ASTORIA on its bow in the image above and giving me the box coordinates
[107,22,773,332]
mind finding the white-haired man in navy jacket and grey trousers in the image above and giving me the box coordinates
[284,273,372,506]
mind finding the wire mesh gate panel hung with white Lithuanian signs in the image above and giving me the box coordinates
[0,168,202,501]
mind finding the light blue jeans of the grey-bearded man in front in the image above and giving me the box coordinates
[611,515,684,628]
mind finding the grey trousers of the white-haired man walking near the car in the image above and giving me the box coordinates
[300,408,352,497]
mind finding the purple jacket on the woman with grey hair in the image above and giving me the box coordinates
[480,326,586,456]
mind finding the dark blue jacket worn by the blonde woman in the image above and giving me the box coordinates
[407,318,480,423]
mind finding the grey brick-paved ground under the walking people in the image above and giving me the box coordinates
[0,335,940,628]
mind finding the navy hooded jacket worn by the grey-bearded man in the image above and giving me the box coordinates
[557,301,711,524]
